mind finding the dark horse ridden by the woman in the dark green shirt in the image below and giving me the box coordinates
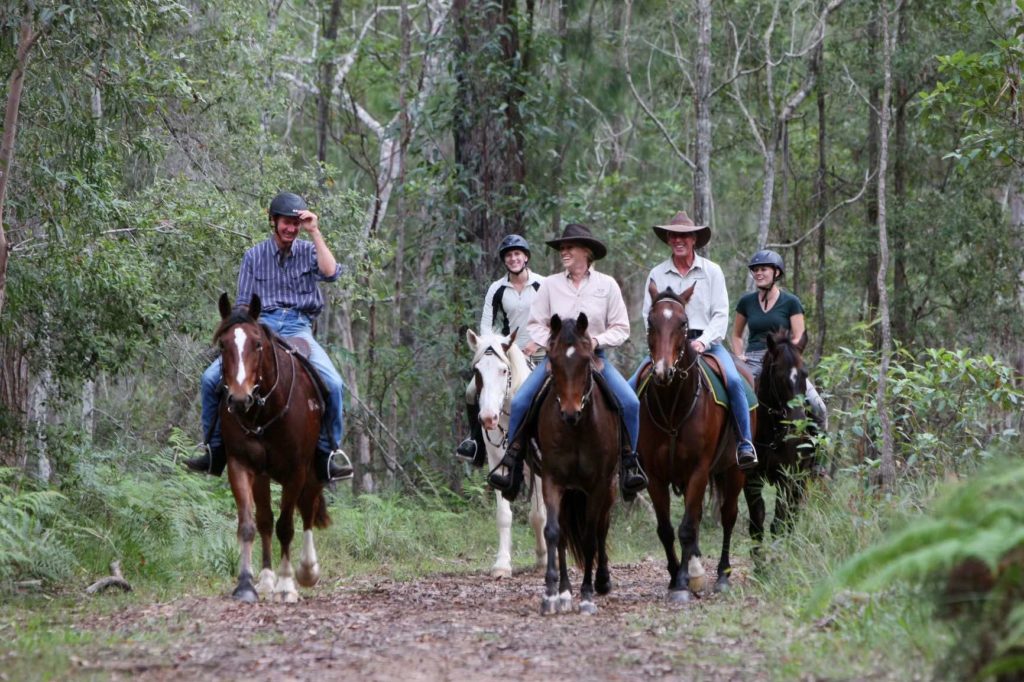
[743,330,814,556]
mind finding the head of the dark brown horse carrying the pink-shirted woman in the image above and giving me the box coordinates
[548,312,599,426]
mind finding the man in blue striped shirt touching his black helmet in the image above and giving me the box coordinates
[185,191,352,481]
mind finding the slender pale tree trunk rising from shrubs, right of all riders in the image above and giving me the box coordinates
[876,0,896,491]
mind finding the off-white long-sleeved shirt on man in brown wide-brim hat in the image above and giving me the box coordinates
[643,256,729,347]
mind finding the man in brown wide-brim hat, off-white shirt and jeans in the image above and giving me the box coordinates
[630,211,758,469]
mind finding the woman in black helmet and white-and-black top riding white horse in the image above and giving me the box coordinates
[455,235,544,467]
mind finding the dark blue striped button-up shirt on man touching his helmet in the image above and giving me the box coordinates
[236,237,341,318]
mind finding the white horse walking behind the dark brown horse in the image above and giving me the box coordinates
[466,330,548,578]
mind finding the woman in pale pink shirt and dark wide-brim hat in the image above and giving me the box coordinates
[488,223,647,500]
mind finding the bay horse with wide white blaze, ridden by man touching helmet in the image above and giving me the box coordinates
[214,294,331,603]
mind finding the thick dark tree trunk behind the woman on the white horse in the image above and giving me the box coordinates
[452,0,526,290]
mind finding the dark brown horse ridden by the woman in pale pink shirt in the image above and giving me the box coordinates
[535,313,620,614]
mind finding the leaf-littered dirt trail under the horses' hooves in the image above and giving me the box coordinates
[75,560,765,682]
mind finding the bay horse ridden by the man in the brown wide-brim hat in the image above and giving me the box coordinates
[637,282,754,602]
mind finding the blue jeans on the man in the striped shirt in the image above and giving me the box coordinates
[201,308,344,453]
